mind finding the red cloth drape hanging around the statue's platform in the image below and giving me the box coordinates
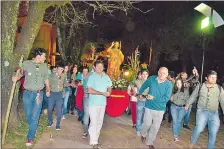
[106,90,129,117]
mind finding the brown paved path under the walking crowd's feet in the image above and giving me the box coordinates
[34,114,224,149]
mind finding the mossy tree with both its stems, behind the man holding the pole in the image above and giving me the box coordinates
[1,1,65,129]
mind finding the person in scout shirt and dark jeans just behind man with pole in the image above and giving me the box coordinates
[47,63,66,130]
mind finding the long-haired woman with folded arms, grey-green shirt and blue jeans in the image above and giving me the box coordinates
[170,79,189,141]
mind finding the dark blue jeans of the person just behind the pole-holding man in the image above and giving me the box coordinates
[48,92,63,127]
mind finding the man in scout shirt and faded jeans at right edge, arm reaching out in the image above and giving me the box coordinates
[185,70,224,149]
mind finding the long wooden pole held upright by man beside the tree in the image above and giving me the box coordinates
[2,55,23,145]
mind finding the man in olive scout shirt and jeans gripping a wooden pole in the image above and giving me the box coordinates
[12,48,50,146]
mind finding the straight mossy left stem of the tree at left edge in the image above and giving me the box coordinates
[1,1,19,128]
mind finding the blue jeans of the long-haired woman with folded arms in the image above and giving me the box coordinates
[171,104,188,137]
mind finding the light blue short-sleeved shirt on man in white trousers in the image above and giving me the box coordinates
[87,72,112,106]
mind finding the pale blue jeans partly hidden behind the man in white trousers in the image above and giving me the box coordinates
[83,97,89,133]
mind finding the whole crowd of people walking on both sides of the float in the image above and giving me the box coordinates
[12,48,224,149]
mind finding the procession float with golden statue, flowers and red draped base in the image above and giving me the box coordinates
[76,41,151,117]
